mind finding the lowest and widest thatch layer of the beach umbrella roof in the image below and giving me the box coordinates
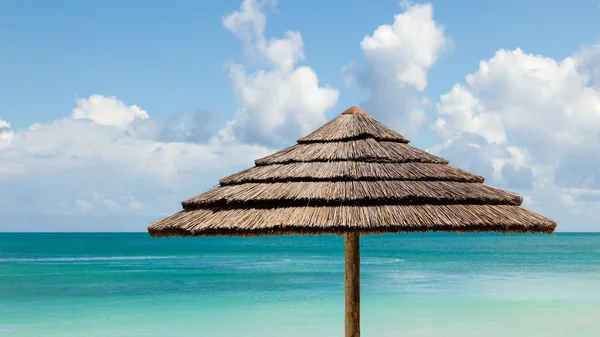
[149,205,554,236]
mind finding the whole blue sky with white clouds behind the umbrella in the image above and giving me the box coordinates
[0,0,600,232]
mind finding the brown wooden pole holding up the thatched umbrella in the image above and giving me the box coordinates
[344,233,360,337]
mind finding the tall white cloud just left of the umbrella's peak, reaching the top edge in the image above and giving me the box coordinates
[222,0,339,145]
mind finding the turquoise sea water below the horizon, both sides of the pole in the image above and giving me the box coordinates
[0,233,600,337]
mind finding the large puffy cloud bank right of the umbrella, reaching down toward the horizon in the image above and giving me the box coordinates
[432,45,600,229]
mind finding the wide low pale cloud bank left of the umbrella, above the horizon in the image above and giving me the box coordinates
[0,95,270,230]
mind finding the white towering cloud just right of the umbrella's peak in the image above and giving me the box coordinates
[345,2,451,136]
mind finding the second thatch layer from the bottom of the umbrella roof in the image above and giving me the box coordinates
[182,180,523,209]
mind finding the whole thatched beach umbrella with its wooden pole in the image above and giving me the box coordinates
[148,107,556,337]
